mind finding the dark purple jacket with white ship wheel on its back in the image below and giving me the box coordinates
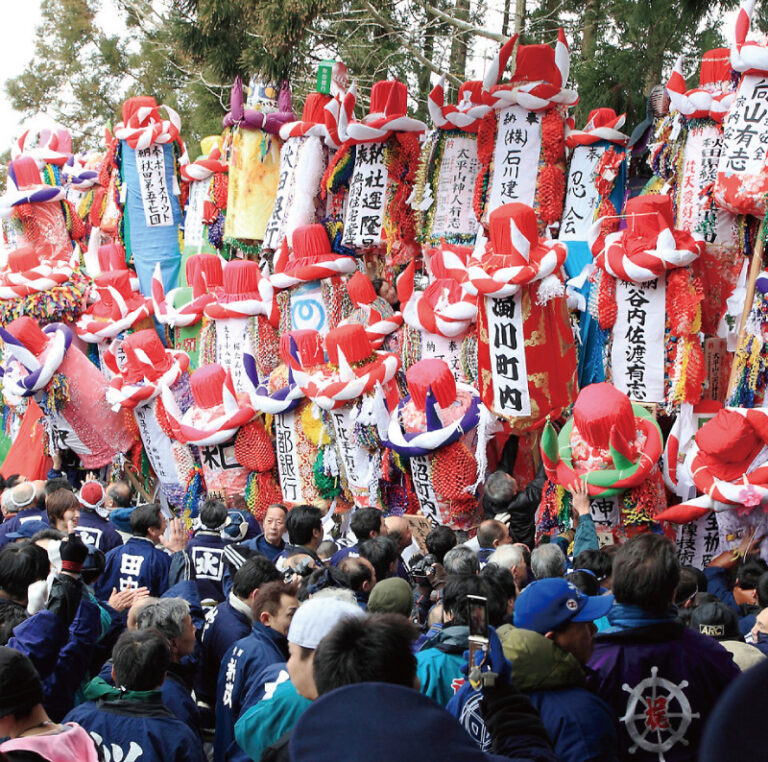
[587,604,739,762]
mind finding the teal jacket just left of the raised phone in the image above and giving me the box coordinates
[416,625,469,706]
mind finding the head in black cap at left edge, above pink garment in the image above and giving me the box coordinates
[0,646,43,738]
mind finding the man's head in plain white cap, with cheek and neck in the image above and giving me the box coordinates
[286,598,365,701]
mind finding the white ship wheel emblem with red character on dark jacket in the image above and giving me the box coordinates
[621,667,700,762]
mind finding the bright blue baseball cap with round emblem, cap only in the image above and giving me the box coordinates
[514,577,613,635]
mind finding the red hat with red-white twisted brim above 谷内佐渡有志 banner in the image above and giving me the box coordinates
[590,195,704,283]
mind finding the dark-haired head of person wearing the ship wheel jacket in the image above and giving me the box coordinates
[613,533,680,614]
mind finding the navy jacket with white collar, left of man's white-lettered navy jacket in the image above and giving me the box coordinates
[195,593,253,707]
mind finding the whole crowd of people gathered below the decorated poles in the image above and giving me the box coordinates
[0,473,768,762]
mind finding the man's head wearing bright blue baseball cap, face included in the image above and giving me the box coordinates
[514,577,613,664]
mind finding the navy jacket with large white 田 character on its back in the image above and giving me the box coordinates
[95,537,171,600]
